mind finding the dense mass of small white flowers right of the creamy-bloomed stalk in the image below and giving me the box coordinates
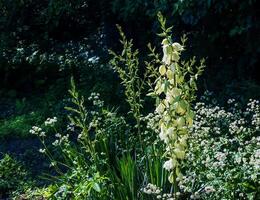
[183,96,260,199]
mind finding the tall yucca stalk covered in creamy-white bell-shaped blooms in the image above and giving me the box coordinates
[147,13,205,197]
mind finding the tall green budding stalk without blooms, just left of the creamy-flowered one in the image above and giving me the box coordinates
[109,25,147,150]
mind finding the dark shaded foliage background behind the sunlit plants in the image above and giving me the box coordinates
[0,0,260,195]
